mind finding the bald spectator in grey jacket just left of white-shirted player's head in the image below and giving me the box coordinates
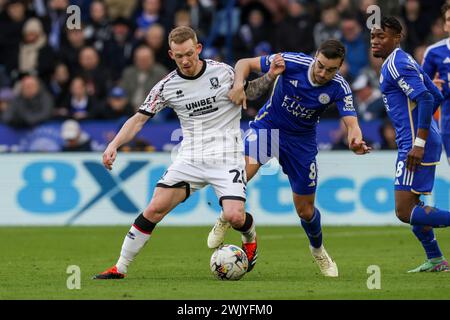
[120,46,168,110]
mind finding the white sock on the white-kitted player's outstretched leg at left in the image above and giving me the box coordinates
[116,226,150,273]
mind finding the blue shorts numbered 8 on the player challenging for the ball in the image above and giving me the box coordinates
[244,125,318,195]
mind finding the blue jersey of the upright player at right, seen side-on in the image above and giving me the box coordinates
[380,48,442,164]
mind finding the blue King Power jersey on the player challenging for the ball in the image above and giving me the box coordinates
[253,53,356,136]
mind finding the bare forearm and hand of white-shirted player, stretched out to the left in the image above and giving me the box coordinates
[103,112,149,170]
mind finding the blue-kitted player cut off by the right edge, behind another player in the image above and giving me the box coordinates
[422,3,450,164]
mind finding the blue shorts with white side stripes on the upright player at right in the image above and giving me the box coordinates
[395,154,436,194]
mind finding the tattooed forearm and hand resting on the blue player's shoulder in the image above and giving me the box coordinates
[245,54,286,100]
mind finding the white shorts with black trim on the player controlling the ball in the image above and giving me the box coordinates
[156,159,247,205]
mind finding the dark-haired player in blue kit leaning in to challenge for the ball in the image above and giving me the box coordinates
[208,39,370,277]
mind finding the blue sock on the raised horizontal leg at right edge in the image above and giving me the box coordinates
[410,205,450,228]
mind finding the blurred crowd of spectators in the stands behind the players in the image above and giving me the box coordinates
[0,0,448,149]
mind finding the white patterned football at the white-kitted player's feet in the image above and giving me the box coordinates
[210,244,248,280]
